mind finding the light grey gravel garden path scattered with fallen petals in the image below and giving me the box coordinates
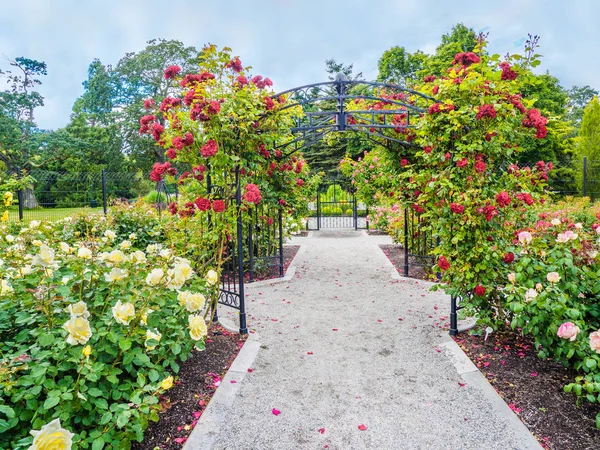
[191,231,540,450]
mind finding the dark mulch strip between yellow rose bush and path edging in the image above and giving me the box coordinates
[132,325,245,450]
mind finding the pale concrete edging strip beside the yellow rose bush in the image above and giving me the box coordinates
[182,330,261,450]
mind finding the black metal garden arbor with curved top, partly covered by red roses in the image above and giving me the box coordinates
[215,74,458,334]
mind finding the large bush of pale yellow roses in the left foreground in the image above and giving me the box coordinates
[0,215,214,450]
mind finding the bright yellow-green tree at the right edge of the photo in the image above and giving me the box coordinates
[577,95,600,195]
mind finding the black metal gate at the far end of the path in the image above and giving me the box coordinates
[306,184,369,230]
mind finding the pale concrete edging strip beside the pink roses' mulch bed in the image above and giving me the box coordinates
[438,340,543,450]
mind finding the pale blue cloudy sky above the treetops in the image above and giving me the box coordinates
[0,0,600,129]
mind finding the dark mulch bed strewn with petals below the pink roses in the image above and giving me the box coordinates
[455,331,600,450]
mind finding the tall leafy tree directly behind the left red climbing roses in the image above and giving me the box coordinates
[112,39,199,170]
